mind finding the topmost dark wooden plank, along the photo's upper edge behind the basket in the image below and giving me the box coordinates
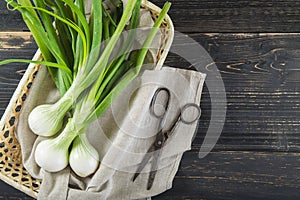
[0,0,300,33]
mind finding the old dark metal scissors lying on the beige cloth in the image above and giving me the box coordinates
[132,87,201,190]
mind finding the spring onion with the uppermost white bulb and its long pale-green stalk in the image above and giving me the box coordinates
[28,0,137,136]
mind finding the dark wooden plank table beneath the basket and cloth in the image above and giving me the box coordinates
[0,0,300,199]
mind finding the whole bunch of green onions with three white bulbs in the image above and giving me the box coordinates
[0,0,170,177]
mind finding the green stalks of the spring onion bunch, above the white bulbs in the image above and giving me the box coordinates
[5,0,170,144]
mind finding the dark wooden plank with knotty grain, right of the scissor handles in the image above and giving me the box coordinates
[165,33,300,151]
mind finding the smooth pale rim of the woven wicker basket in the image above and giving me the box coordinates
[0,0,174,199]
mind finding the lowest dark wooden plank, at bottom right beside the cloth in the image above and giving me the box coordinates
[153,151,300,200]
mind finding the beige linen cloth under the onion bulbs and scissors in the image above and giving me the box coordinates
[16,67,205,200]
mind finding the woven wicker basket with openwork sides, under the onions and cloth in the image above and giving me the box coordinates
[0,0,174,198]
